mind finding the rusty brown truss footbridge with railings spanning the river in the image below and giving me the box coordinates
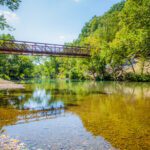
[0,40,90,57]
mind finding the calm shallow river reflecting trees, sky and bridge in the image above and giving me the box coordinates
[0,80,150,150]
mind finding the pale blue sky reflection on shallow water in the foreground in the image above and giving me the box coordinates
[5,113,112,150]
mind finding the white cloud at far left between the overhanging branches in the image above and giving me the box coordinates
[0,11,19,23]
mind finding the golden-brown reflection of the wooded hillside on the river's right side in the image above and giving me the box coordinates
[70,94,150,150]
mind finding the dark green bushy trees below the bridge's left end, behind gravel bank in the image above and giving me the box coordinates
[0,55,34,80]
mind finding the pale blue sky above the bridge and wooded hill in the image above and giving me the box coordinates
[0,0,120,44]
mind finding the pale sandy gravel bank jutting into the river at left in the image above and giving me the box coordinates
[0,79,24,90]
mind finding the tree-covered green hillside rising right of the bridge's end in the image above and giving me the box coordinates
[68,0,150,81]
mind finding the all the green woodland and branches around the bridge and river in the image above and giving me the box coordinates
[0,0,150,82]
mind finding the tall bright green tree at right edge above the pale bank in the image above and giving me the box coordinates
[111,0,150,74]
